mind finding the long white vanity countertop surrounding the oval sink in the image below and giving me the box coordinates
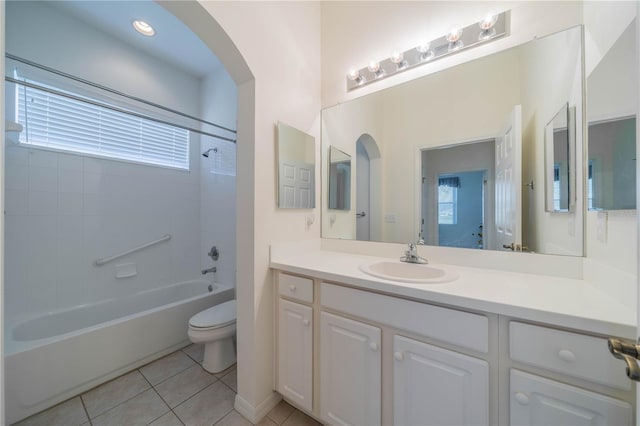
[271,250,636,339]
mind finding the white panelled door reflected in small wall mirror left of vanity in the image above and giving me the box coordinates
[278,161,314,209]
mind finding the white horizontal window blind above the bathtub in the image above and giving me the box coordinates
[17,80,189,170]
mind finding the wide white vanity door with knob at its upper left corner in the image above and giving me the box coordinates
[393,336,489,426]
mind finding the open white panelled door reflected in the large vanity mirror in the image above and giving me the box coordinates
[495,105,522,250]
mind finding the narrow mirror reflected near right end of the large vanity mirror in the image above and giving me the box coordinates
[544,104,575,212]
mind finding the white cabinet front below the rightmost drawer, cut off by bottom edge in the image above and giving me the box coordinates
[509,370,633,426]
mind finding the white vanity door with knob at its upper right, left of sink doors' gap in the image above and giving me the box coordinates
[320,312,381,426]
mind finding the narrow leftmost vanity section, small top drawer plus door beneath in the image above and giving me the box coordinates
[277,274,313,411]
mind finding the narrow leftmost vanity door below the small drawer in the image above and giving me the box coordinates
[278,299,313,411]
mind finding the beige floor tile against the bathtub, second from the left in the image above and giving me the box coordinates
[82,371,150,418]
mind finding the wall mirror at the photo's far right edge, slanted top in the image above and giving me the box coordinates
[587,20,638,210]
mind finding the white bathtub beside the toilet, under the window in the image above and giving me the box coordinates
[5,279,234,424]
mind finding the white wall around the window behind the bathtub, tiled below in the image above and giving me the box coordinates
[4,2,201,321]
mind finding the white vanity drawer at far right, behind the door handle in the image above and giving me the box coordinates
[509,321,631,390]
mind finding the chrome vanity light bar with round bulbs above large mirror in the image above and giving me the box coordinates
[347,11,510,91]
